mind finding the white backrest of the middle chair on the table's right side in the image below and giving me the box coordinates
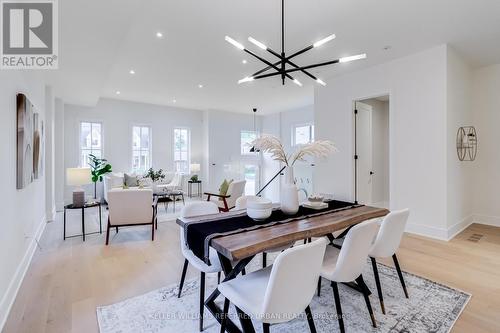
[325,220,378,282]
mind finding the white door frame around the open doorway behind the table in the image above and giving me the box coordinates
[351,91,394,207]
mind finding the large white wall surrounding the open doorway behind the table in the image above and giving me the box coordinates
[314,45,447,238]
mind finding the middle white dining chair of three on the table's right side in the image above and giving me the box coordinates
[321,220,378,332]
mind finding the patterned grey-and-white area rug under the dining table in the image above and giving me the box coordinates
[97,259,471,333]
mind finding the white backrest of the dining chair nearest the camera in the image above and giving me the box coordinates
[262,238,328,324]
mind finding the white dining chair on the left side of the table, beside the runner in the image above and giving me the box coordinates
[177,201,222,332]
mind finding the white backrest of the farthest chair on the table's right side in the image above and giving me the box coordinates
[369,209,410,258]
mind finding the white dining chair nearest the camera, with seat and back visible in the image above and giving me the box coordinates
[218,238,328,333]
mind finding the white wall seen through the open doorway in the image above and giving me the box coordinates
[362,98,389,205]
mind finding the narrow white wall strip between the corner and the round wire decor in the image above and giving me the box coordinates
[446,47,476,238]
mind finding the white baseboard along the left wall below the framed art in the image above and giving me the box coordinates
[0,216,47,331]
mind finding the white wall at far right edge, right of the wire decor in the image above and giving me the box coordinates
[471,64,500,226]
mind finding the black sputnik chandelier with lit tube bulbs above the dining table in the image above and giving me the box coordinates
[225,0,366,86]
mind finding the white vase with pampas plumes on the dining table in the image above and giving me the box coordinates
[251,134,337,215]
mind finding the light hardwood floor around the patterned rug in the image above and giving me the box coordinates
[3,208,500,333]
